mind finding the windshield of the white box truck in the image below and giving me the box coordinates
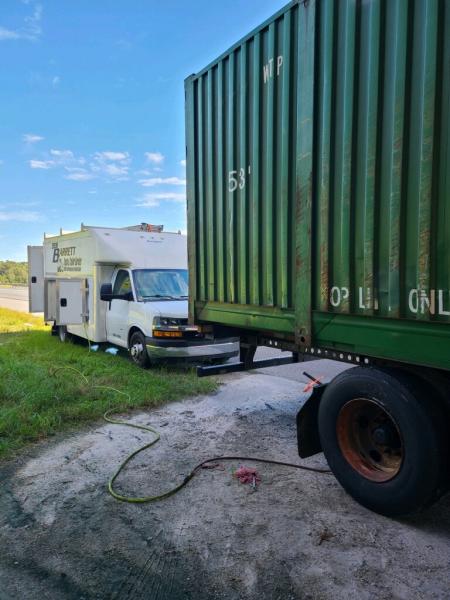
[133,269,189,301]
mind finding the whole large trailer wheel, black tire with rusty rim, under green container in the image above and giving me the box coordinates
[318,367,448,517]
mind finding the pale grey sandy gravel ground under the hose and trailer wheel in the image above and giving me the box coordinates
[0,361,450,600]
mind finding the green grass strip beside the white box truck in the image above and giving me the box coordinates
[0,308,217,458]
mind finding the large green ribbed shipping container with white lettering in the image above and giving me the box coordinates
[185,0,450,370]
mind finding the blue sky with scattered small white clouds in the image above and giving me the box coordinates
[0,0,287,260]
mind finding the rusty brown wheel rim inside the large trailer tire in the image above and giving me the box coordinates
[336,398,404,483]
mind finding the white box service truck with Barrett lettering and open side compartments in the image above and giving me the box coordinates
[28,224,239,367]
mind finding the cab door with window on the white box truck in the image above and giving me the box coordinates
[106,269,133,348]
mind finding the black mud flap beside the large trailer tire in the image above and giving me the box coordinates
[297,383,327,458]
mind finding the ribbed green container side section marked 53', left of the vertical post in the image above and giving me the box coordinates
[187,4,299,314]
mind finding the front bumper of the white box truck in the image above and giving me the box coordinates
[146,338,239,361]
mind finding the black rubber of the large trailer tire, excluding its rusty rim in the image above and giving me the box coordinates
[318,367,448,517]
